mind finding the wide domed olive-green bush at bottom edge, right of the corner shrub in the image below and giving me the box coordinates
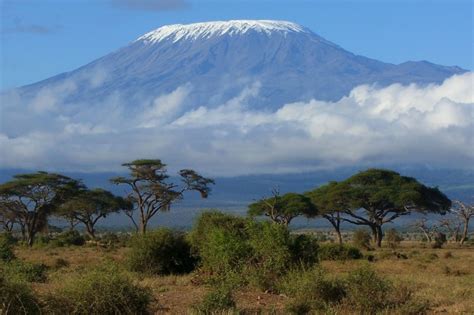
[45,266,152,314]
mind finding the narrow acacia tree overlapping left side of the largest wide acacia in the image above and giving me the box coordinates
[306,181,350,244]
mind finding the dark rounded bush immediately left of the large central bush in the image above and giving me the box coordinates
[128,228,196,275]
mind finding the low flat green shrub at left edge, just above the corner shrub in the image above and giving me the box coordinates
[0,259,48,282]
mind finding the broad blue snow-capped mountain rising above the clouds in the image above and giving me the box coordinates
[15,20,465,109]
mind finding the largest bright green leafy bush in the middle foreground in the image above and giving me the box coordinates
[190,211,317,289]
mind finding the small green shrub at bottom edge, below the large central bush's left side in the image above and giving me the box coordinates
[195,286,235,314]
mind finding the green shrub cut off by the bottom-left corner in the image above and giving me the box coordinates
[0,273,41,314]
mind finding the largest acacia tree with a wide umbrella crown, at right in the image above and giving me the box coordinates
[342,169,451,247]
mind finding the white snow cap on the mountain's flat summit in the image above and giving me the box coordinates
[137,20,308,43]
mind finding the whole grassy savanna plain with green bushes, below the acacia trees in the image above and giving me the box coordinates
[0,211,474,314]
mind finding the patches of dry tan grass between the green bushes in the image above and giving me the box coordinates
[12,242,474,314]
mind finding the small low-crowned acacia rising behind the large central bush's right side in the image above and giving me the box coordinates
[247,190,317,226]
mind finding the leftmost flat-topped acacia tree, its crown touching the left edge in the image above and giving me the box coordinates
[0,172,82,246]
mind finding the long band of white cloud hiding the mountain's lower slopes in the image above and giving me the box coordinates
[0,72,474,175]
